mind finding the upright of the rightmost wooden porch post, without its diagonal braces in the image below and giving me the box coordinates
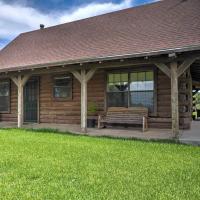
[170,61,179,138]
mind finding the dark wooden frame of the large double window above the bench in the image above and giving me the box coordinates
[105,65,157,117]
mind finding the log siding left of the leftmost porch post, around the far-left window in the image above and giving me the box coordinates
[0,81,17,122]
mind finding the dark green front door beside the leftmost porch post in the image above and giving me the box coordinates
[24,77,39,122]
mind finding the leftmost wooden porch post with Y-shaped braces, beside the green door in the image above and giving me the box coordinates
[11,75,30,128]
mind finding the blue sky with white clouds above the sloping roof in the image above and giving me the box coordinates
[0,0,157,49]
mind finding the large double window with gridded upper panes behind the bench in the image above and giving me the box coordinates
[107,71,154,112]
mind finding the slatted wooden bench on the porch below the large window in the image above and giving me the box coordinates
[98,107,148,132]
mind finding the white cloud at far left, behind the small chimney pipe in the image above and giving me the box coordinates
[0,1,55,38]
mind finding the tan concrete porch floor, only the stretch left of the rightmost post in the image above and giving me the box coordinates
[0,122,172,140]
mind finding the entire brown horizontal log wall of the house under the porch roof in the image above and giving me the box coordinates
[0,67,192,128]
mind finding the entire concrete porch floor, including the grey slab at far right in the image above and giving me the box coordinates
[0,121,200,145]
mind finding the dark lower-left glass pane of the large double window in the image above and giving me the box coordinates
[107,92,128,107]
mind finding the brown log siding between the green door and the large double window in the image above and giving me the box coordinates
[40,71,104,124]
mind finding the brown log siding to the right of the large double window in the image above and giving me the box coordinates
[149,70,191,129]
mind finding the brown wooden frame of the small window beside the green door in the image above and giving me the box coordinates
[52,73,73,101]
